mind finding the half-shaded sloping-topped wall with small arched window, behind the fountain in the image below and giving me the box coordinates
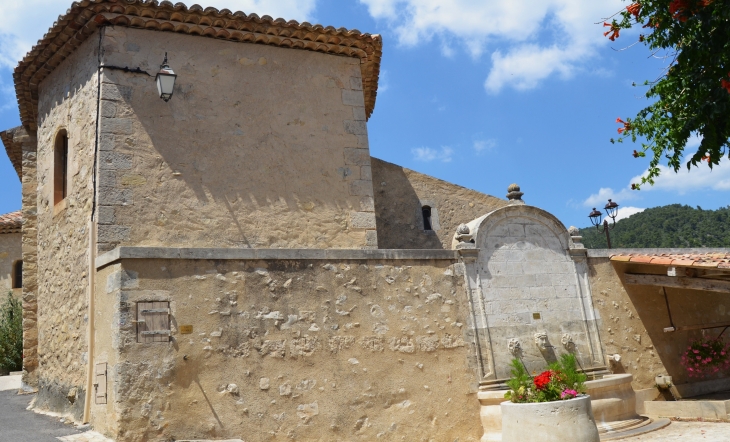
[371,158,507,249]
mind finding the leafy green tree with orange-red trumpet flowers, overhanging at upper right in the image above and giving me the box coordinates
[604,0,730,189]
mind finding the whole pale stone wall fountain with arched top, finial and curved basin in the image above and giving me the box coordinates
[453,198,664,441]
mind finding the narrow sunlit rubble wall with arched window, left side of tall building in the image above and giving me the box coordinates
[33,32,99,418]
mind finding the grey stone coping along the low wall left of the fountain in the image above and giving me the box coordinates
[96,246,459,269]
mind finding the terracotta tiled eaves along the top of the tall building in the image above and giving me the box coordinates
[13,0,383,130]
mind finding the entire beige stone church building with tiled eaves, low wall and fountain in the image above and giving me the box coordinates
[0,0,724,441]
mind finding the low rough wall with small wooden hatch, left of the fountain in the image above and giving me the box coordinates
[92,260,482,442]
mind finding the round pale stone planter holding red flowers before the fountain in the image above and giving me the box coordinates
[500,396,600,442]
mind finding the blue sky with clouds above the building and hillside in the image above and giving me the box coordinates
[0,0,730,227]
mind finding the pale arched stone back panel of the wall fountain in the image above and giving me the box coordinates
[456,204,603,384]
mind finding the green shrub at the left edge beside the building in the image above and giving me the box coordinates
[0,293,23,371]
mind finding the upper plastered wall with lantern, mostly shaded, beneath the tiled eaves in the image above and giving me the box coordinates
[98,27,377,251]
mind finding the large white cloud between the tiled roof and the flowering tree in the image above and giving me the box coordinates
[359,0,625,93]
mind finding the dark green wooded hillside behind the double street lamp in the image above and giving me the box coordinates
[580,204,730,249]
